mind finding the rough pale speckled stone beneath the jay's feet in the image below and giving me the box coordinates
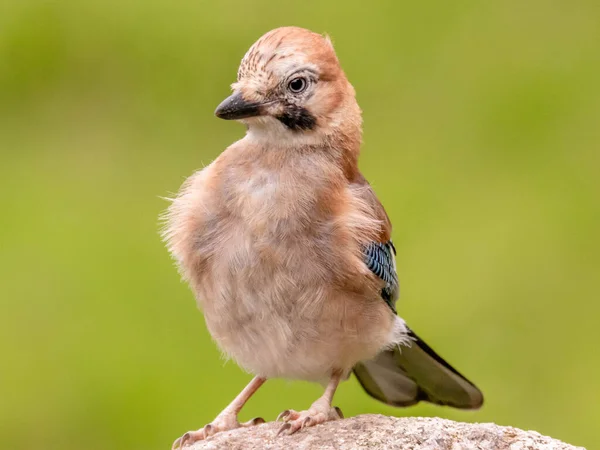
[186,414,583,450]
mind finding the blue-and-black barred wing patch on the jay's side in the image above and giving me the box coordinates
[363,241,399,314]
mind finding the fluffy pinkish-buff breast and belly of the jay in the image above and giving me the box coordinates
[172,152,391,379]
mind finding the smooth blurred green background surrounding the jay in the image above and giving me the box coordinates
[0,0,600,450]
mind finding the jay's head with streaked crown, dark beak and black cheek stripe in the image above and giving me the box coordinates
[215,27,361,148]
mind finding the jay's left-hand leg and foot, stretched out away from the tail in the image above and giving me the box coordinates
[172,376,266,450]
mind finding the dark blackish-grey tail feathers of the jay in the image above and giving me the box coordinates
[354,329,483,409]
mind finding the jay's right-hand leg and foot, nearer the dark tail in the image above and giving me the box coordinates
[277,372,344,435]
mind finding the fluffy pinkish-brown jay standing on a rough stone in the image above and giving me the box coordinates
[163,27,483,449]
